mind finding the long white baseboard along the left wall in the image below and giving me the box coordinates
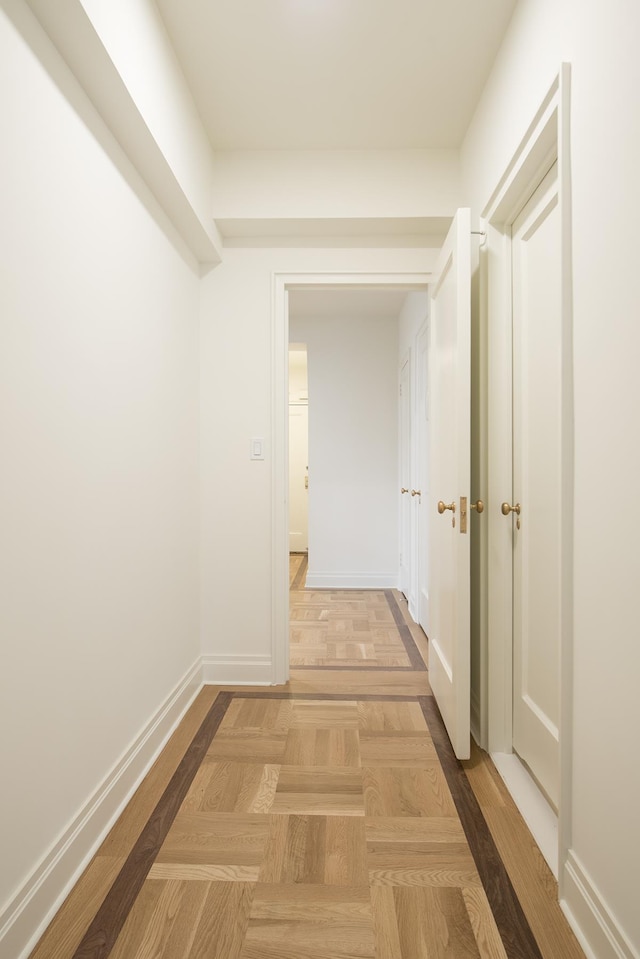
[0,657,202,959]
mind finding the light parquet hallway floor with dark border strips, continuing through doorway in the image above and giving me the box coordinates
[32,569,584,959]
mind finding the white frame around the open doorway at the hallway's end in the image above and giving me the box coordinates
[271,272,431,685]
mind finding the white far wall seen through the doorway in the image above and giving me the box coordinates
[289,316,399,588]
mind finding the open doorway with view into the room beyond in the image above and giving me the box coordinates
[289,289,428,669]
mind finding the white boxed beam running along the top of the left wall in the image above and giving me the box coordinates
[23,0,221,264]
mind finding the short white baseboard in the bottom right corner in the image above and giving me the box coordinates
[560,850,640,959]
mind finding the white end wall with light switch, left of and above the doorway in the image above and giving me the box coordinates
[201,249,435,682]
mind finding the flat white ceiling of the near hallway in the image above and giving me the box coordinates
[156,0,516,150]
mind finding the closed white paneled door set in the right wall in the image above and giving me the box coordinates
[510,165,562,808]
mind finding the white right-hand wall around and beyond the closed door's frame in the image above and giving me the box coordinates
[462,0,640,959]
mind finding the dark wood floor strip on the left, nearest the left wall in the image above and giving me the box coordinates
[73,692,233,959]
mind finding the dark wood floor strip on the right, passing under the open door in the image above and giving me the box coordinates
[417,696,542,959]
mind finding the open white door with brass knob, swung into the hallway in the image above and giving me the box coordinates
[429,209,471,759]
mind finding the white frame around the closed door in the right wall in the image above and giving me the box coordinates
[481,64,574,884]
